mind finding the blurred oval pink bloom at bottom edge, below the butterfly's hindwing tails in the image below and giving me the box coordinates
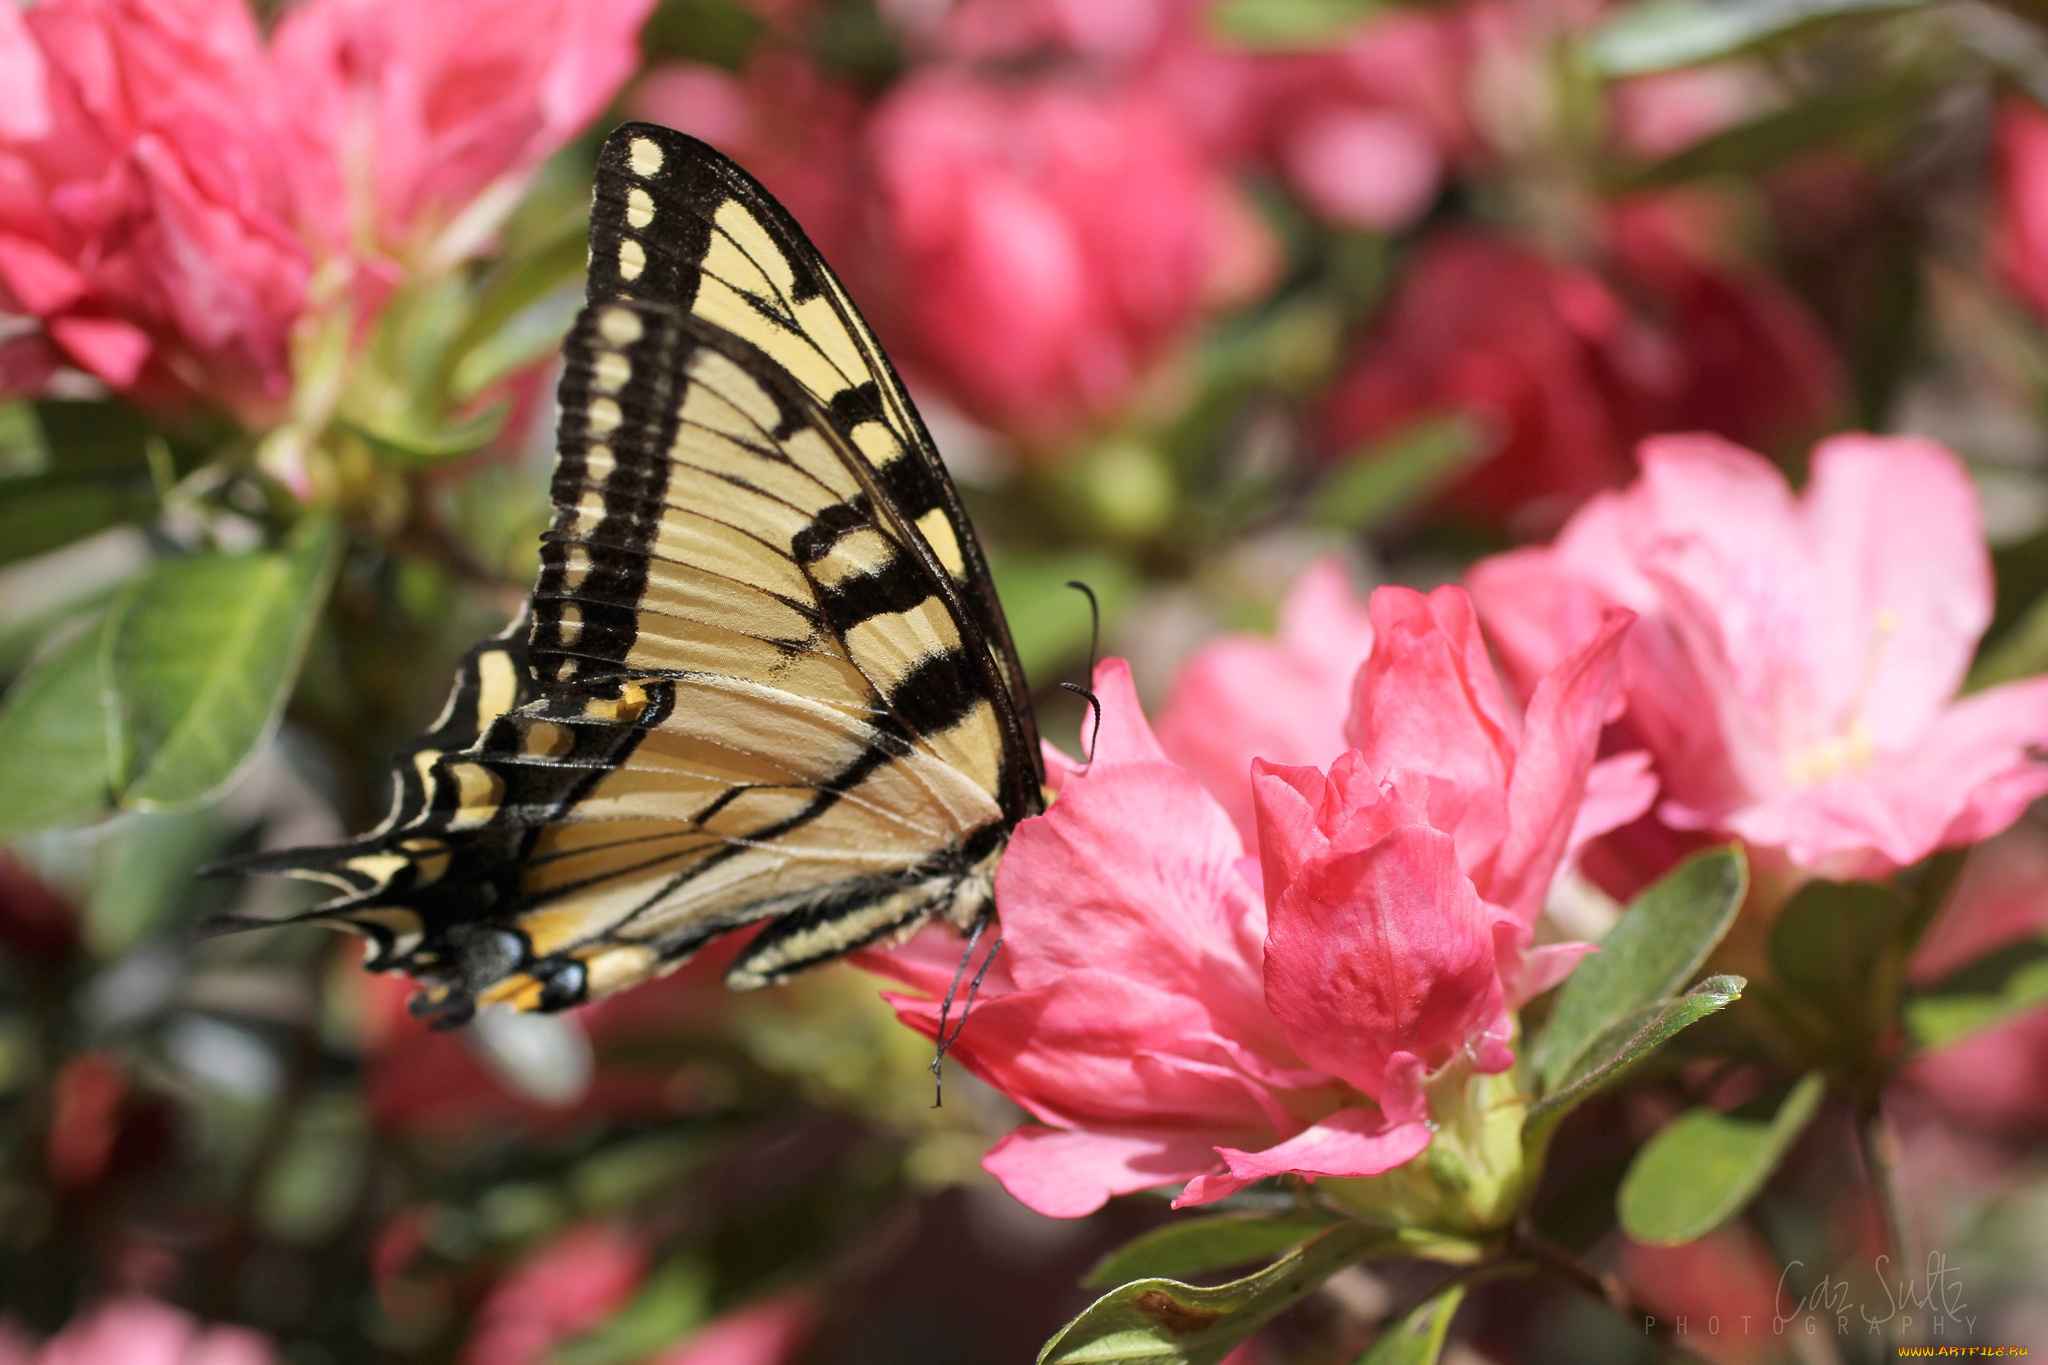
[461,1224,647,1365]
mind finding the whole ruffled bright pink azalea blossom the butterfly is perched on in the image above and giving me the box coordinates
[864,589,1640,1216]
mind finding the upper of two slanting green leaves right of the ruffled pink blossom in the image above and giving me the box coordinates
[1534,845,1749,1091]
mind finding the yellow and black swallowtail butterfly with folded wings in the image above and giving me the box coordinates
[224,123,1044,1023]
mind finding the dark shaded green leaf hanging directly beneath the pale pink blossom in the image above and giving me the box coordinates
[1765,882,1915,1070]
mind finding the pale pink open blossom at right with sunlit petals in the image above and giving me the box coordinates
[1470,436,2048,876]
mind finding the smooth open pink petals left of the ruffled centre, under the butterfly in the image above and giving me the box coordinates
[864,659,1430,1218]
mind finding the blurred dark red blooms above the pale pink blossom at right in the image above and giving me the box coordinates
[1323,218,1841,530]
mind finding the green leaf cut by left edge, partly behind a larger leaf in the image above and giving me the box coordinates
[0,622,113,839]
